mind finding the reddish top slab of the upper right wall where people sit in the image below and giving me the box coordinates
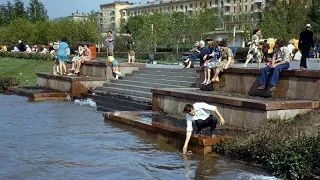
[196,67,320,78]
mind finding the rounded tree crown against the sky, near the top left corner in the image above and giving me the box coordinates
[27,0,49,22]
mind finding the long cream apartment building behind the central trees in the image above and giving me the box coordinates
[120,0,265,31]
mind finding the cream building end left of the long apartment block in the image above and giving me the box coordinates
[98,1,133,33]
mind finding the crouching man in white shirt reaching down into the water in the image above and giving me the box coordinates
[183,102,225,154]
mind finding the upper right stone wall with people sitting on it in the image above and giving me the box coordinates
[196,68,320,100]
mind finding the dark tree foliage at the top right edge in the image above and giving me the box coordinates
[308,0,320,38]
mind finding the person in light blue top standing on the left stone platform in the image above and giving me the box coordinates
[57,38,70,75]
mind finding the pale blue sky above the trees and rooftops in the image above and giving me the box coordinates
[0,0,137,19]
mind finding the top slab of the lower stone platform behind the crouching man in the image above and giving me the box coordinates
[151,89,319,111]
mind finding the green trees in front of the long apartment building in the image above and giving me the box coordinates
[117,9,219,51]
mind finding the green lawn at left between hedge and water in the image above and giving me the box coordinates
[0,58,53,86]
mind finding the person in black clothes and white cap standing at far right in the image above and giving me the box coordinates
[298,24,314,70]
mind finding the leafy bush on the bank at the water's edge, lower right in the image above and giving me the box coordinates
[213,116,320,179]
